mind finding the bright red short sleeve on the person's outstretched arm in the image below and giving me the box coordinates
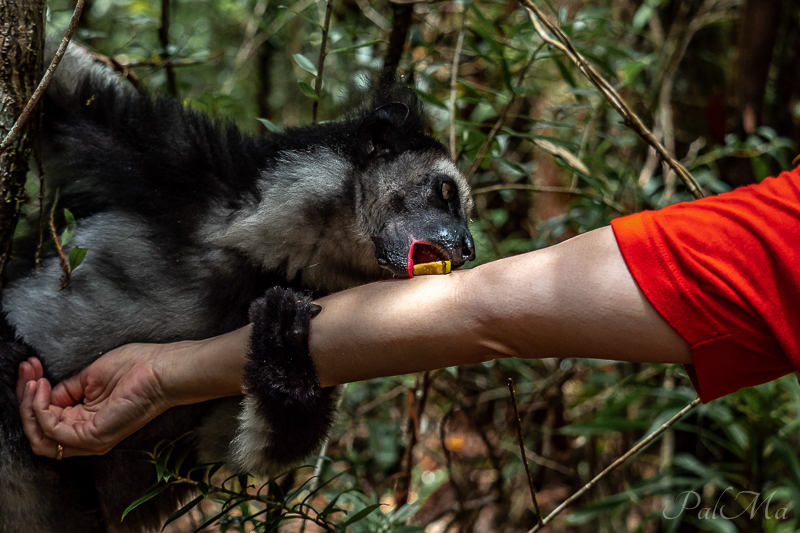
[611,167,800,402]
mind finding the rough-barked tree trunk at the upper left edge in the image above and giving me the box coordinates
[0,0,44,288]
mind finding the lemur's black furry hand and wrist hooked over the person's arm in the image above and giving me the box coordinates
[244,287,335,464]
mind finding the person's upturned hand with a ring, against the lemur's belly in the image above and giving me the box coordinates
[17,344,171,457]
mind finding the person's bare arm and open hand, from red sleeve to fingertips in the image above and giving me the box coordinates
[17,227,691,457]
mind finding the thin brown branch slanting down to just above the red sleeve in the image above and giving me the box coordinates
[520,0,705,198]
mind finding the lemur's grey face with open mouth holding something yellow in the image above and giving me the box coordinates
[361,150,475,278]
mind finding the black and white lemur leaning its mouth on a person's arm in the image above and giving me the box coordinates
[0,47,474,533]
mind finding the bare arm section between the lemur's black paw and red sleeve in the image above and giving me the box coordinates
[310,222,691,385]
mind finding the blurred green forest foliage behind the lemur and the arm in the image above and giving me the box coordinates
[29,0,800,533]
